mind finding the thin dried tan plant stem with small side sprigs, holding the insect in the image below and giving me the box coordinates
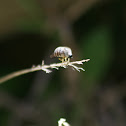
[0,59,90,84]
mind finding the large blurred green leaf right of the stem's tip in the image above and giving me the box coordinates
[81,26,113,86]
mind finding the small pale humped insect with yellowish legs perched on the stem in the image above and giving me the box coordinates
[50,46,72,62]
